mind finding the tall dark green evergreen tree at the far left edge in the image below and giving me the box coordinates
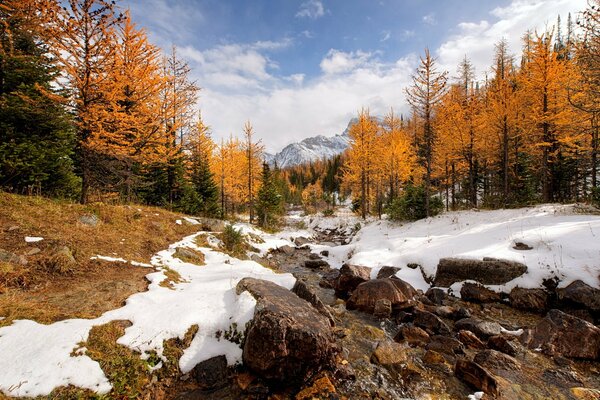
[0,1,77,197]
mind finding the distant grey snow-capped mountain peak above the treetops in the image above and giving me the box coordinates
[264,118,356,168]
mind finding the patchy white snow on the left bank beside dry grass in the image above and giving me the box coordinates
[0,222,295,397]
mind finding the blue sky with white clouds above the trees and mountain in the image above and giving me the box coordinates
[120,0,586,152]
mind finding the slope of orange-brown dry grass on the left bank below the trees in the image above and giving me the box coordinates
[0,192,198,326]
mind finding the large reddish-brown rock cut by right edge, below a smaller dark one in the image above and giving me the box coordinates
[520,310,600,360]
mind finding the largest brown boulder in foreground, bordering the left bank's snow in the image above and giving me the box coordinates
[236,278,339,383]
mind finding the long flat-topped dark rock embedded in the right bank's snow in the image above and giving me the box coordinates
[434,258,527,287]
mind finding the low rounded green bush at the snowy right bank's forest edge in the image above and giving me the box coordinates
[387,184,444,221]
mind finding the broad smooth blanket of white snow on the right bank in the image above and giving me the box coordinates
[311,205,600,291]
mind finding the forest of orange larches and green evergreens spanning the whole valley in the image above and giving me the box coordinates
[0,0,600,225]
